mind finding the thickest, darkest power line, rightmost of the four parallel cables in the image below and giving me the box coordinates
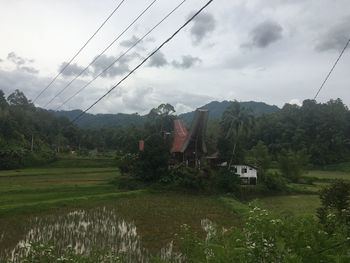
[72,0,214,123]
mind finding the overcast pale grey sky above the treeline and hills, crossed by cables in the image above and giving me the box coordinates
[0,0,350,114]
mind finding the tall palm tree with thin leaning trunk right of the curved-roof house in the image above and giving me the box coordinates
[221,101,253,169]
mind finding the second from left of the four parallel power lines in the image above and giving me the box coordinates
[44,0,158,108]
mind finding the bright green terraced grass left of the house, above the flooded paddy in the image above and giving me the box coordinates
[0,159,130,215]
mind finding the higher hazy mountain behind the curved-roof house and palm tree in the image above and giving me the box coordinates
[180,100,280,124]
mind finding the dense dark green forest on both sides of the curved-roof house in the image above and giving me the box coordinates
[0,90,350,169]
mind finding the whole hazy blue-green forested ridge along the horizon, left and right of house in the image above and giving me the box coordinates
[55,101,279,129]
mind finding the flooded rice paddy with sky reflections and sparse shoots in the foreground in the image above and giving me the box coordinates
[0,193,239,262]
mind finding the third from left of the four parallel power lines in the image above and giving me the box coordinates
[55,0,187,111]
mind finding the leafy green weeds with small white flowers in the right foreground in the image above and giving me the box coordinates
[175,207,350,263]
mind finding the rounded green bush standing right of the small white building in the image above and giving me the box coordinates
[278,151,308,182]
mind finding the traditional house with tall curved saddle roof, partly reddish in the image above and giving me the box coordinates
[170,109,208,168]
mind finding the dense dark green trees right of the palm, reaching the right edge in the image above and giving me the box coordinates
[252,99,350,165]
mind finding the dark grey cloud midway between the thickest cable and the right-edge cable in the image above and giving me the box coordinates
[242,20,283,48]
